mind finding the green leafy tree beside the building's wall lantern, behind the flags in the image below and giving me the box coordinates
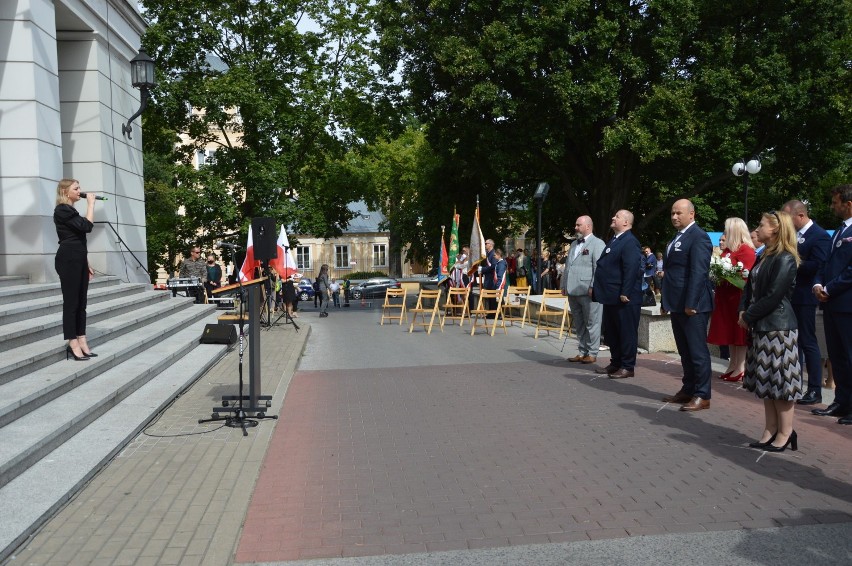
[142,0,392,242]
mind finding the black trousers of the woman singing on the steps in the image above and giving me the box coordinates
[54,244,89,340]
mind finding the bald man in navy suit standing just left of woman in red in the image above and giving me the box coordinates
[661,199,713,411]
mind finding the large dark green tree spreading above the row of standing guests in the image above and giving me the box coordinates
[378,0,852,243]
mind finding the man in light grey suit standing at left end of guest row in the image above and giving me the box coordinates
[562,216,606,364]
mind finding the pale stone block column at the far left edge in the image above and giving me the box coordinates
[0,0,62,281]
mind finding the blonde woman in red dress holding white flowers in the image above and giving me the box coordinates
[707,218,755,381]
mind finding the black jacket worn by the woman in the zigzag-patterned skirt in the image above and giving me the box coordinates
[740,252,798,332]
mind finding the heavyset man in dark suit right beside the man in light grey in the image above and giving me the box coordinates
[592,210,642,379]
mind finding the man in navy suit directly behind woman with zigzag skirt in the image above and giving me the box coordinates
[783,200,831,405]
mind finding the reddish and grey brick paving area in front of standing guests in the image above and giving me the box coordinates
[237,355,852,562]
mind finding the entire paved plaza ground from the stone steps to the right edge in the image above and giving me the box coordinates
[8,308,852,565]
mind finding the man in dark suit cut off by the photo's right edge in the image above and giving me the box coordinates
[808,185,852,424]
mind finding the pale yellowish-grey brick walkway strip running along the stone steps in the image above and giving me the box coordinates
[11,327,309,566]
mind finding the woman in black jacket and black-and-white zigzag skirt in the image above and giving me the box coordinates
[739,212,802,452]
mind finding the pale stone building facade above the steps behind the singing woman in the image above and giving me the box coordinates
[0,0,149,282]
